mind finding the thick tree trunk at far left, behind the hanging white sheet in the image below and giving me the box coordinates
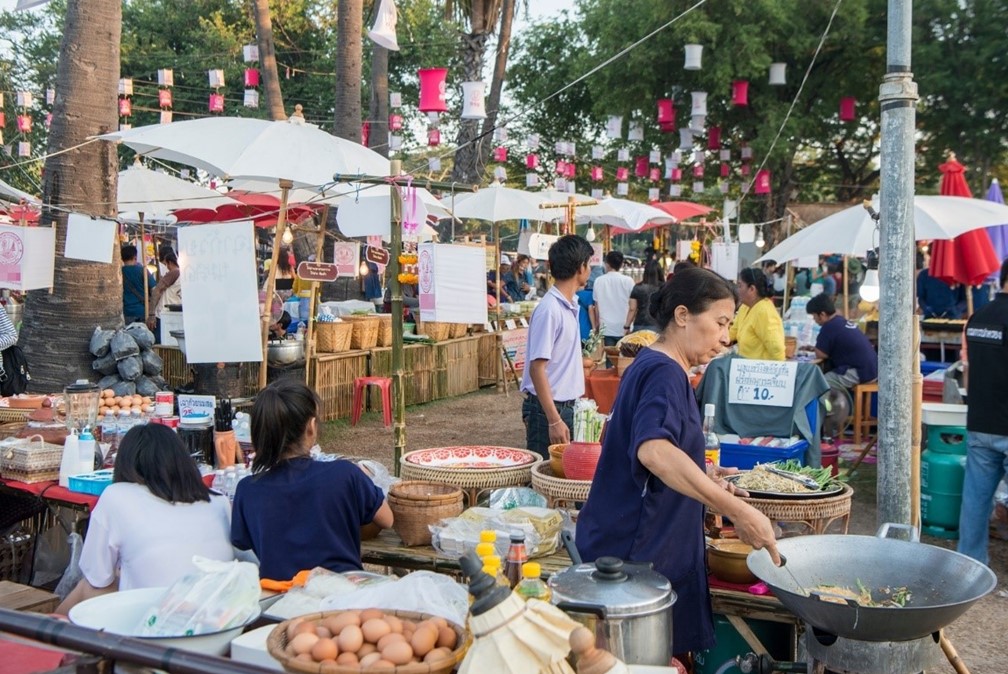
[20,0,123,391]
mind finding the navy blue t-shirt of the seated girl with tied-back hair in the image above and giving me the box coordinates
[231,457,384,580]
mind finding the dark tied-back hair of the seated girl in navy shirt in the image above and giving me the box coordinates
[252,378,321,473]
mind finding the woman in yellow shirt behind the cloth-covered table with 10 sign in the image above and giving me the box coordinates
[729,267,784,361]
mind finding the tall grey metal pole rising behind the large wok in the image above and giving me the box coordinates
[877,0,917,524]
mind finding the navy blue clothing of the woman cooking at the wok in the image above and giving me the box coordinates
[577,349,715,653]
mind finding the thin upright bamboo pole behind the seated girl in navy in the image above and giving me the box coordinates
[388,159,405,477]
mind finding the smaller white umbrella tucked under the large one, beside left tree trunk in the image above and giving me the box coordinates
[117,164,238,219]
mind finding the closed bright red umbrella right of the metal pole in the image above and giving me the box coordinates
[927,154,1001,285]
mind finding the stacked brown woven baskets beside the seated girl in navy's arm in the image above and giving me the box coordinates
[388,480,463,546]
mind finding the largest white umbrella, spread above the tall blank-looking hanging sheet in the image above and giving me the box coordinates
[99,116,389,187]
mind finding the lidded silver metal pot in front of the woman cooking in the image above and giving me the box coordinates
[549,557,676,667]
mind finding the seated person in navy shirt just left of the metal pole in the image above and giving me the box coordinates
[805,293,879,389]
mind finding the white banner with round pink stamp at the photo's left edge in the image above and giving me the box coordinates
[0,226,56,290]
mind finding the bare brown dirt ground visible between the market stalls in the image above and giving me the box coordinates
[322,388,1008,674]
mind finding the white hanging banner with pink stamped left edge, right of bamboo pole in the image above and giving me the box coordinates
[416,244,487,324]
